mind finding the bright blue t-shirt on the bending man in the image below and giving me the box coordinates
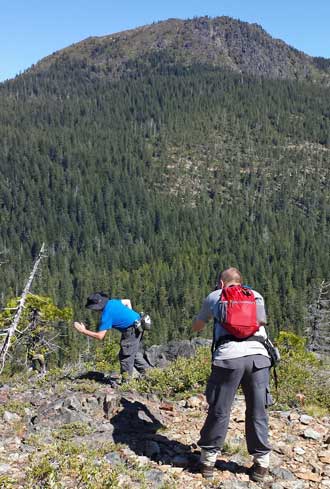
[99,299,140,331]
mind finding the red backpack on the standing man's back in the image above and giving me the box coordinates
[220,285,259,339]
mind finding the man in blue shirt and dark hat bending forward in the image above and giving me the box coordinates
[74,292,150,377]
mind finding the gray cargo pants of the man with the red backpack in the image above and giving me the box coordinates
[198,355,272,455]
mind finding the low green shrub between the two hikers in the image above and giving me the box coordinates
[123,348,211,398]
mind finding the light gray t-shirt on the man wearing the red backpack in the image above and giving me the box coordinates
[196,289,268,366]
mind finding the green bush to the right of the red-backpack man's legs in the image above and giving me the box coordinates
[277,332,330,410]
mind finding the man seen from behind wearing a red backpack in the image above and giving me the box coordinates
[192,268,272,482]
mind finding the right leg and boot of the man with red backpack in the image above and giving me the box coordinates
[242,355,271,480]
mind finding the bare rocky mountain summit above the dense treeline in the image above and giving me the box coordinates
[29,16,330,81]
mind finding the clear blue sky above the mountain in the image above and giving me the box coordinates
[0,0,330,81]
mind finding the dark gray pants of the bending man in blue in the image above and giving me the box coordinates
[119,326,150,376]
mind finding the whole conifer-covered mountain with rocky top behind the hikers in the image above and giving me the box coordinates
[0,17,330,358]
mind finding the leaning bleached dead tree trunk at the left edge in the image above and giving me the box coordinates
[0,243,45,374]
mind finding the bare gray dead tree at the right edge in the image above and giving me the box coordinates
[306,280,330,355]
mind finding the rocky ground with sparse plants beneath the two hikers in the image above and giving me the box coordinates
[0,375,330,489]
